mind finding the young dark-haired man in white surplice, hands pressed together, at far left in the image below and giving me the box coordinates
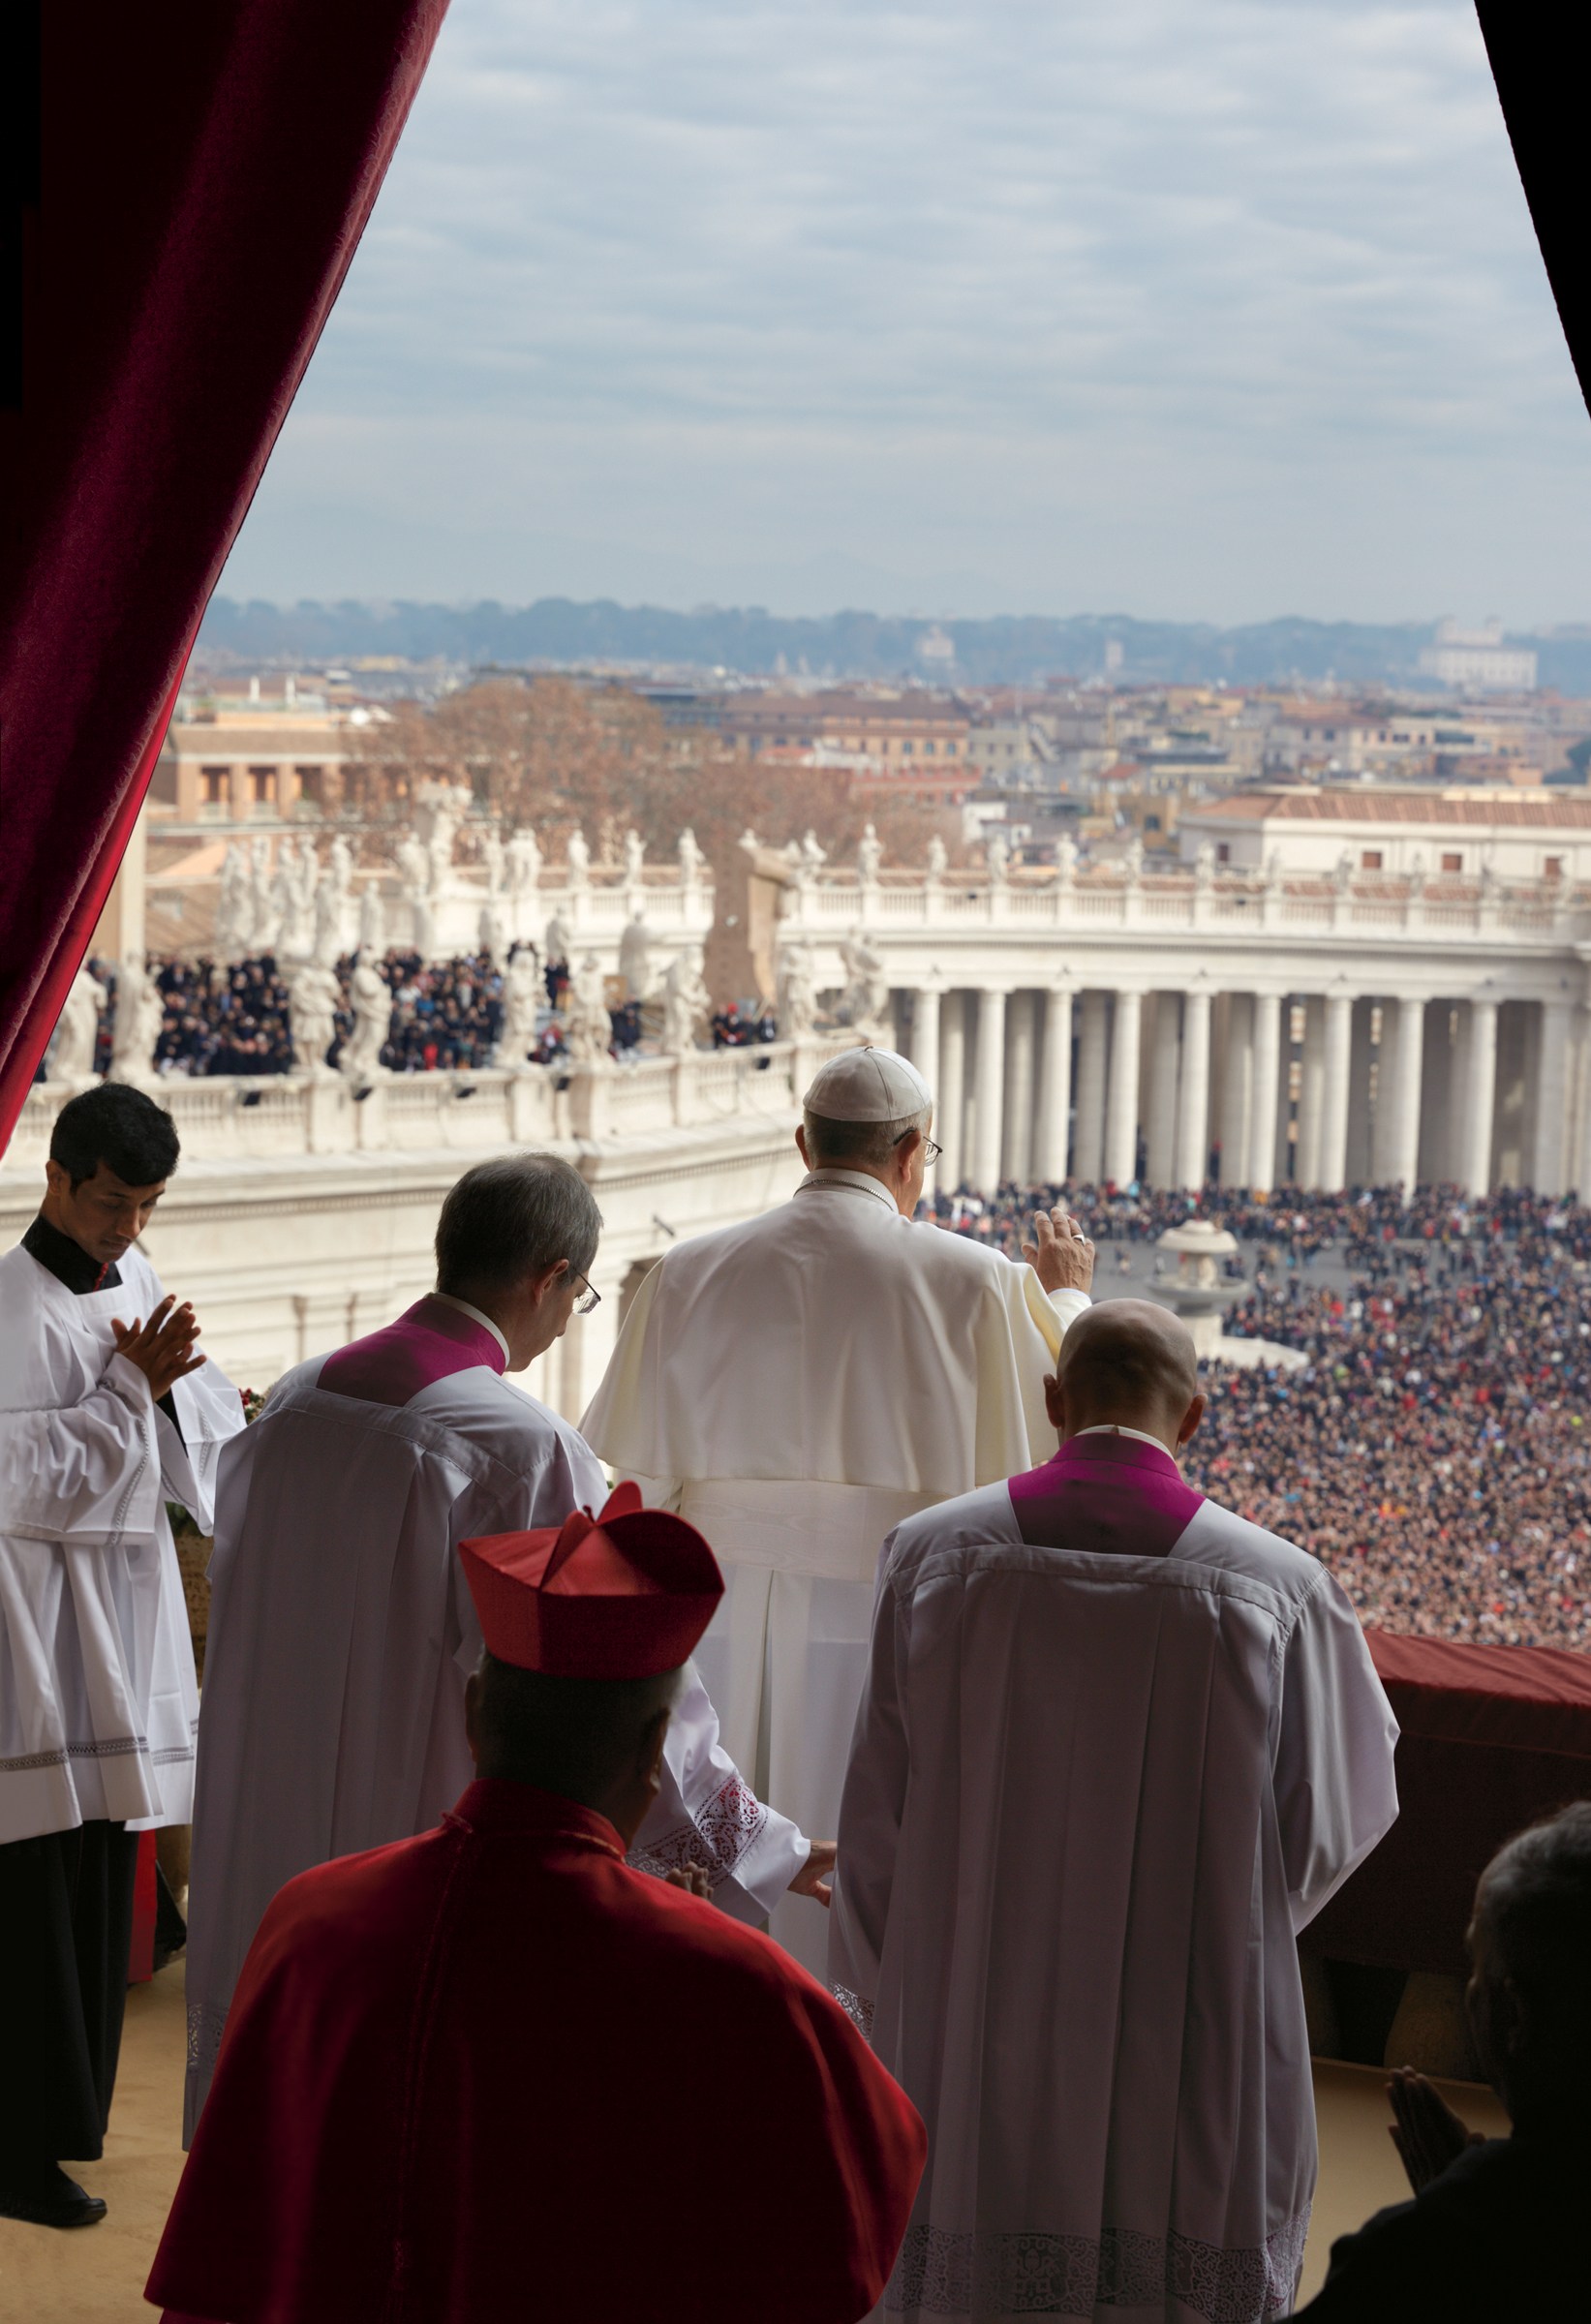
[0,1083,244,2226]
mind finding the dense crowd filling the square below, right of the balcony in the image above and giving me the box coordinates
[938,1187,1591,1652]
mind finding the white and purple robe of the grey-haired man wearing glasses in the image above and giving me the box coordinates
[183,1297,817,2143]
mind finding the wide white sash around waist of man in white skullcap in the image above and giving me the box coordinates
[681,1476,943,1585]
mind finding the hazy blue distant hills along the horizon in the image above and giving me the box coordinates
[199,597,1591,695]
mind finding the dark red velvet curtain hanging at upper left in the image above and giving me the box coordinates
[0,0,446,1146]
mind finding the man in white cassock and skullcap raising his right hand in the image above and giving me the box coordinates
[581,1048,1094,1975]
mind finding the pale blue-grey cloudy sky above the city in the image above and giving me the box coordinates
[221,0,1591,626]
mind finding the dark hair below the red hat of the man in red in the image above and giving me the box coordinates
[464,1650,678,1799]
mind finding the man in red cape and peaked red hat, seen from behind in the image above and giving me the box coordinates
[146,1487,922,2324]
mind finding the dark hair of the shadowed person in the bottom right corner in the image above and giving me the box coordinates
[1475,1799,1591,2052]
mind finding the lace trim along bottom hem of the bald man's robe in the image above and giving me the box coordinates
[882,2212,1310,2324]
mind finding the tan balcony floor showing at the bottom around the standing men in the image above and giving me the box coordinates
[0,1962,1508,2324]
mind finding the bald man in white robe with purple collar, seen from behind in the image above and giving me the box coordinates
[829,1300,1398,2324]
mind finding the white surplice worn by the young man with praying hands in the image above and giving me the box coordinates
[0,1243,244,1841]
